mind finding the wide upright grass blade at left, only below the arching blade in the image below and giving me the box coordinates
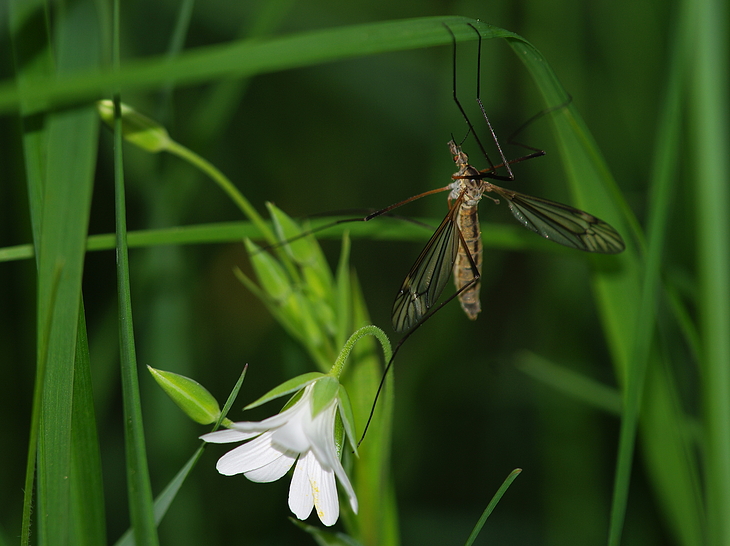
[38,84,98,544]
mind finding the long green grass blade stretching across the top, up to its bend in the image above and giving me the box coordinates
[0,17,514,112]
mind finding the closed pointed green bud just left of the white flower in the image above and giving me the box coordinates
[147,366,221,425]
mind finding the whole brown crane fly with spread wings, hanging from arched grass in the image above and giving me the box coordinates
[391,24,624,332]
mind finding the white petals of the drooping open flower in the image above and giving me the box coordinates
[201,381,357,525]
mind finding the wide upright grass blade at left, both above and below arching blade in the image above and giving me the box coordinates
[36,0,98,546]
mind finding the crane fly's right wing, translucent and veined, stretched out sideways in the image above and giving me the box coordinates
[492,184,624,254]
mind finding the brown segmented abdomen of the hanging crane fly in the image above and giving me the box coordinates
[454,205,482,320]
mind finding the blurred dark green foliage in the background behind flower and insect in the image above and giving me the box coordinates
[0,0,724,546]
